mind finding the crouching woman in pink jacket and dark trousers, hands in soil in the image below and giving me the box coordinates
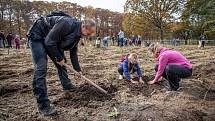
[148,43,192,91]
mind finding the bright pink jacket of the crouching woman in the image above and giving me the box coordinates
[155,48,192,81]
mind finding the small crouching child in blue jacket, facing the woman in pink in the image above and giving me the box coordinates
[118,53,144,83]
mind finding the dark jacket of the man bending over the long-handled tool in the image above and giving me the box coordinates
[28,16,81,71]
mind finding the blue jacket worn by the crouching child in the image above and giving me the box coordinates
[119,58,142,80]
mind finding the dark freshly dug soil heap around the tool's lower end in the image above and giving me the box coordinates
[53,83,117,108]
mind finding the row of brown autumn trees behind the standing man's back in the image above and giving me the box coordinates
[0,0,123,37]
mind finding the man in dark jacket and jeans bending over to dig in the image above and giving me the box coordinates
[28,12,96,116]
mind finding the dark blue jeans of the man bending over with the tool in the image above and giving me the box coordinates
[29,40,73,104]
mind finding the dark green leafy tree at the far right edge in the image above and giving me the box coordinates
[182,0,215,38]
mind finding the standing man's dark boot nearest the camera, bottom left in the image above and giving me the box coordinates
[38,103,57,116]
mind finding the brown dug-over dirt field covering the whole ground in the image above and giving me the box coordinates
[0,46,215,121]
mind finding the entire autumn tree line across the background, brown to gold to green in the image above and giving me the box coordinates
[0,0,215,40]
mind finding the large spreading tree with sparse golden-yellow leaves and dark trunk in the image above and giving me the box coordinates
[125,0,183,40]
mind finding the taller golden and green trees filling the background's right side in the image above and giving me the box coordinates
[123,0,215,40]
